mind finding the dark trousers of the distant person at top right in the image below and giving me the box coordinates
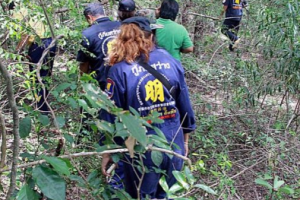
[221,19,241,42]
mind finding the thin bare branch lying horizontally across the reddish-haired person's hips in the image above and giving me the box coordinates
[0,146,192,173]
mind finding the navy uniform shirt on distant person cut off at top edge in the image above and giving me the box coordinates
[223,0,243,21]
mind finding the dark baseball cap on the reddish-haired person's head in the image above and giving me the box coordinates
[122,16,163,32]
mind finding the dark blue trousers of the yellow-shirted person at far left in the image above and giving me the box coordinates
[28,38,56,112]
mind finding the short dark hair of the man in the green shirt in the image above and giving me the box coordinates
[159,0,179,21]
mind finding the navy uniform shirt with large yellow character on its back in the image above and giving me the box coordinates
[101,49,196,151]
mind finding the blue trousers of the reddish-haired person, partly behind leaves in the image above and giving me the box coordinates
[124,150,183,199]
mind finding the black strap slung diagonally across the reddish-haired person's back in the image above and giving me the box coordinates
[138,59,175,99]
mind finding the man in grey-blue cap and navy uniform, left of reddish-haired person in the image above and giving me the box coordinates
[77,2,120,90]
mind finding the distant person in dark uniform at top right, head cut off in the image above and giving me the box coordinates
[220,0,247,51]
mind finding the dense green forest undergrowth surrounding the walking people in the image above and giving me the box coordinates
[0,0,300,200]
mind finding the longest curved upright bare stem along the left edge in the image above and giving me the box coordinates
[0,61,20,200]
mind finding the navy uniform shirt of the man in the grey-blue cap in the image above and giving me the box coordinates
[77,17,121,87]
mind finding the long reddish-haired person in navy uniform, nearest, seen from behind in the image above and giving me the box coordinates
[101,17,196,199]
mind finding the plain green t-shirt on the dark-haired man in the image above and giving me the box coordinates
[156,18,193,60]
